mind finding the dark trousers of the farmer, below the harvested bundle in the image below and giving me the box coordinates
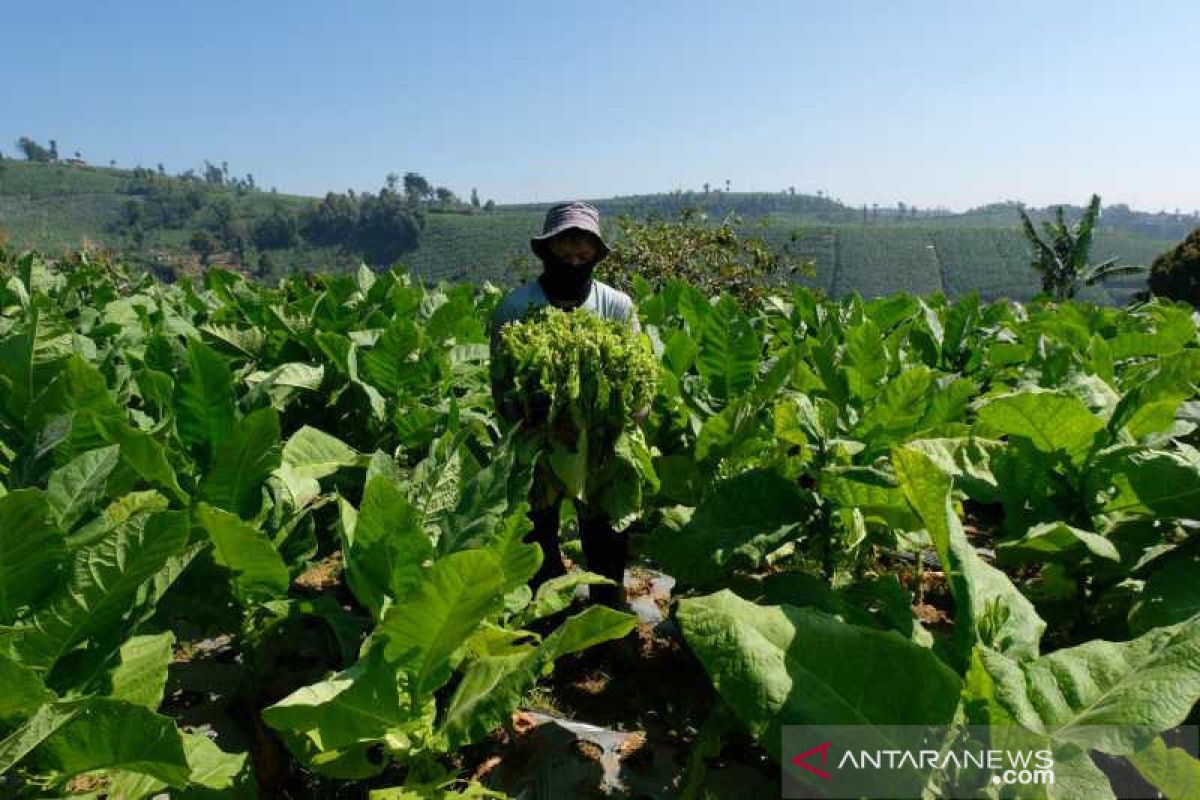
[524,498,629,606]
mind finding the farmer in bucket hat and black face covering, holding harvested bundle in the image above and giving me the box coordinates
[492,203,644,607]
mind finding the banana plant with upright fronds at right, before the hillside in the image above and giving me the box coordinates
[1018,194,1145,300]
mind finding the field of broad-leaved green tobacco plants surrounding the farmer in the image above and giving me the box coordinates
[0,245,1200,798]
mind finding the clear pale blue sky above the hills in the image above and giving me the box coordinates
[9,0,1200,210]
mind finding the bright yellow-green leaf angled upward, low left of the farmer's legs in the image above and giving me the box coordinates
[377,551,504,698]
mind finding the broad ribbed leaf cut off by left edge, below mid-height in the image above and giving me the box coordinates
[0,489,66,625]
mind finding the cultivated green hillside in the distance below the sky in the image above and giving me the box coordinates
[0,160,1180,302]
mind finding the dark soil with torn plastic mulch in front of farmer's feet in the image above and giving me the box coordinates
[456,569,780,800]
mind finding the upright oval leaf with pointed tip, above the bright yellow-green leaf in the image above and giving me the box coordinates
[342,475,433,619]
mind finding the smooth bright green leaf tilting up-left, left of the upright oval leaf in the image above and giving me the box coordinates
[196,503,288,604]
